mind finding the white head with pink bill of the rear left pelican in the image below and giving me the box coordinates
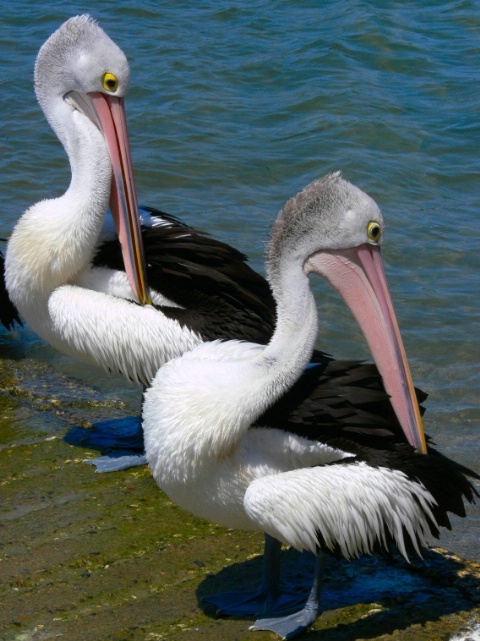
[35,15,149,303]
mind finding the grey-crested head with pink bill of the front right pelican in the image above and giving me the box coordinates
[267,172,427,453]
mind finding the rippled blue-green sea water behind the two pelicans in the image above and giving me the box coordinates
[0,0,480,560]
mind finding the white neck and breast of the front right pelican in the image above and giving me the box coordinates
[143,248,317,488]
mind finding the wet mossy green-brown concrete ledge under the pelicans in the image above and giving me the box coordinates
[0,358,480,641]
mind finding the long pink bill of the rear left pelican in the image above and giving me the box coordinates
[89,92,151,305]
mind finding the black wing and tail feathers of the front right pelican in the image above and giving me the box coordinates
[253,360,480,532]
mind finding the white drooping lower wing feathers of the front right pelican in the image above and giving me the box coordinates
[245,462,435,559]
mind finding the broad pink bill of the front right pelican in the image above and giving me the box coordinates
[305,245,427,454]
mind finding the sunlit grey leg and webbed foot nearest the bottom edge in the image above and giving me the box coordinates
[250,552,326,639]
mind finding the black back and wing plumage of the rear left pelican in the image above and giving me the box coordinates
[93,207,275,348]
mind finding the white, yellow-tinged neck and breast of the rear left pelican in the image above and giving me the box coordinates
[6,98,111,316]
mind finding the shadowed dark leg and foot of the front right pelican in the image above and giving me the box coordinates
[203,534,316,617]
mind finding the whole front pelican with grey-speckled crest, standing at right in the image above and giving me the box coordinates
[143,172,478,639]
